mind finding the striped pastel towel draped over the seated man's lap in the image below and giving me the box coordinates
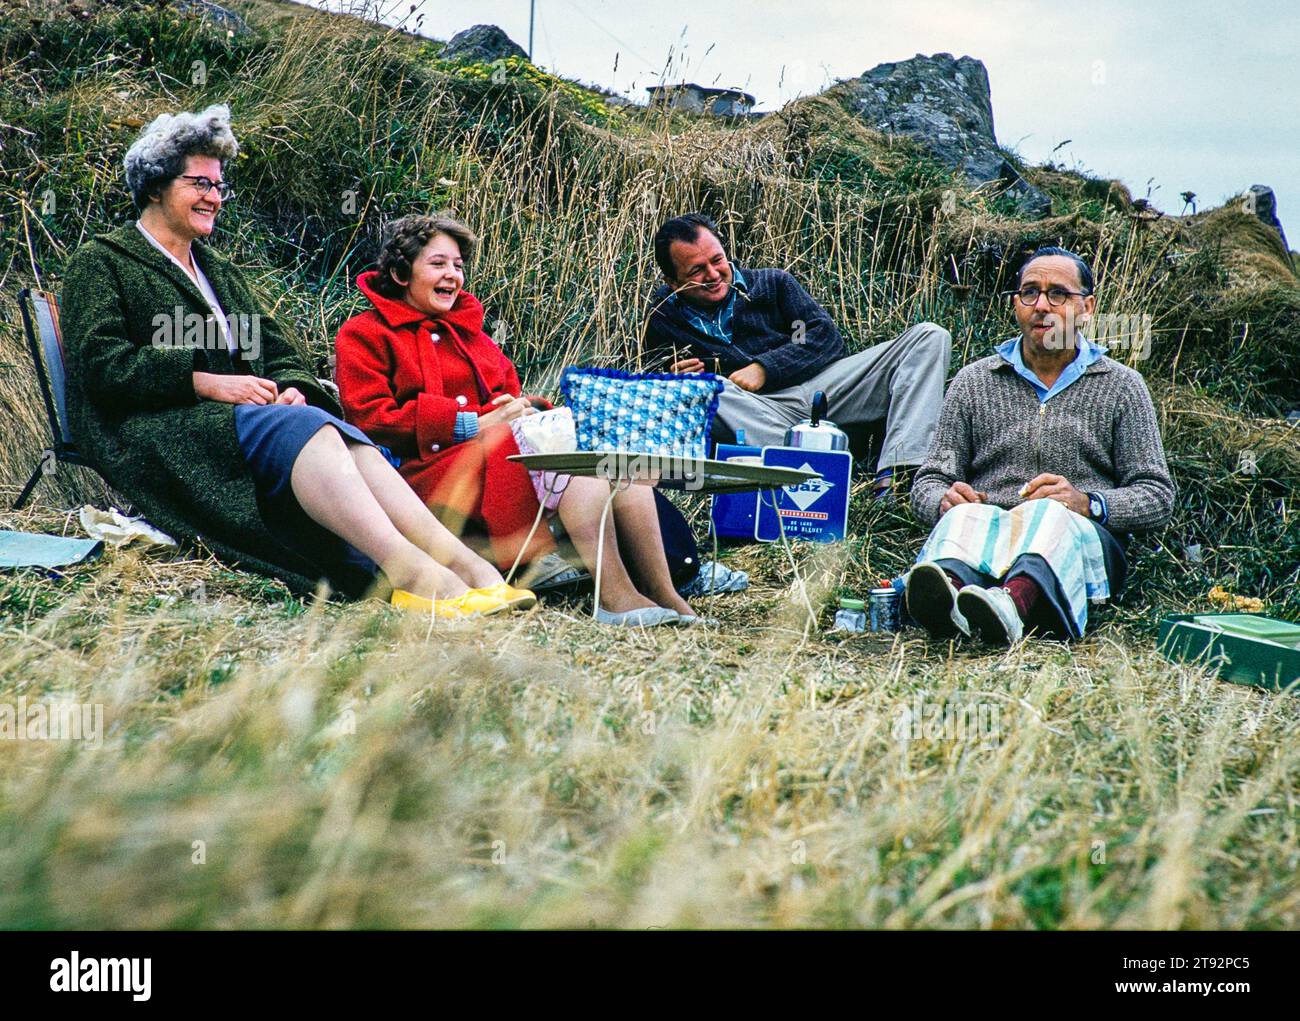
[917,499,1110,635]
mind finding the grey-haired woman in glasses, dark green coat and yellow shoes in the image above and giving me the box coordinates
[64,107,534,617]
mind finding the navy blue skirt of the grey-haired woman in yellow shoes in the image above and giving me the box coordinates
[235,404,387,596]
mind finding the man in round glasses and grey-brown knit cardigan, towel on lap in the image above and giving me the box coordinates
[906,247,1174,645]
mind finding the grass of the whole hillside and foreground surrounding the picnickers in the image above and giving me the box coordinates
[0,3,1300,927]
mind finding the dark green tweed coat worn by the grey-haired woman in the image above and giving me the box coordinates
[61,222,342,592]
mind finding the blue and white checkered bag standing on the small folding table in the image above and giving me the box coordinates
[560,367,723,458]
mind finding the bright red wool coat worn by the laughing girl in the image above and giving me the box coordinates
[334,271,554,568]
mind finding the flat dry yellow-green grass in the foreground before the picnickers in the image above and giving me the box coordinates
[0,507,1300,929]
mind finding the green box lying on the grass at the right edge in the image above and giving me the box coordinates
[1156,614,1300,693]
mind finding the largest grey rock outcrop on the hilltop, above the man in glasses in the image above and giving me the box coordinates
[835,53,1052,217]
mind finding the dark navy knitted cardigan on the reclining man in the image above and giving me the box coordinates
[642,268,844,390]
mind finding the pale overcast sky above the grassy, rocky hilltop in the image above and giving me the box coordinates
[301,0,1300,247]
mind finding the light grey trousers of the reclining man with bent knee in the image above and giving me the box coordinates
[718,323,953,468]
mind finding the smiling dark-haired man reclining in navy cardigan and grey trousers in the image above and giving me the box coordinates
[642,213,952,493]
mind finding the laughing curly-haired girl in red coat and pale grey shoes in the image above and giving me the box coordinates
[334,216,696,626]
